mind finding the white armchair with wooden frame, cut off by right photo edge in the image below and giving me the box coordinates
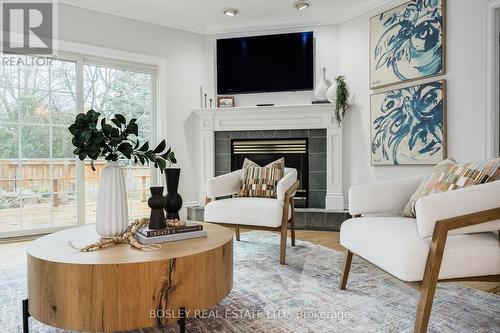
[340,177,500,332]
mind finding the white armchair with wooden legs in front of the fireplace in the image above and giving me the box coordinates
[204,168,299,265]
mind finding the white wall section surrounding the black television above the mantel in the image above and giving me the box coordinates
[206,25,339,106]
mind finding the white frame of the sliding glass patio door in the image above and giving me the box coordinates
[0,34,167,240]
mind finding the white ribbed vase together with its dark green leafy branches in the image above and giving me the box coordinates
[69,110,177,237]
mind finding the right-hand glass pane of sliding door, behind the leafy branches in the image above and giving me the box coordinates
[83,64,152,222]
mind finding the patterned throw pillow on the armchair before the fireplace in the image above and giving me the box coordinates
[238,158,285,198]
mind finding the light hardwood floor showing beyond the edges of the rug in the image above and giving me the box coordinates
[0,229,500,295]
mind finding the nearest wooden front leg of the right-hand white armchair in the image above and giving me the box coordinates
[413,224,448,333]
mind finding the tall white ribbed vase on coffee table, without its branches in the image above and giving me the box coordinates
[96,161,128,237]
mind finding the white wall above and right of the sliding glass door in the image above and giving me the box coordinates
[59,4,206,202]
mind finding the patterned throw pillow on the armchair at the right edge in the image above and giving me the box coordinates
[403,157,500,217]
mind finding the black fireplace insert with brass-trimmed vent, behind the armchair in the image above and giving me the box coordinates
[231,138,309,208]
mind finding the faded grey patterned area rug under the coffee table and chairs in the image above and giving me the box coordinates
[0,232,500,333]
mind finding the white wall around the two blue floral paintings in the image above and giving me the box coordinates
[339,0,487,198]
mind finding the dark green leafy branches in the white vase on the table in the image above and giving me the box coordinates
[68,110,177,173]
